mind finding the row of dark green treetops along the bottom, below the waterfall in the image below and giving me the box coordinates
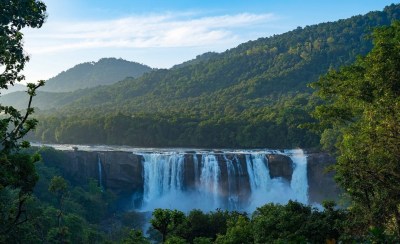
[151,201,348,244]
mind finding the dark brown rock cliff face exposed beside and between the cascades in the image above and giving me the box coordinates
[43,151,340,202]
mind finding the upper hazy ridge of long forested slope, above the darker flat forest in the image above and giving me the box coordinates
[46,5,400,114]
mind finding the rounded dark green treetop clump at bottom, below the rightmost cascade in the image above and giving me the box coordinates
[253,201,346,243]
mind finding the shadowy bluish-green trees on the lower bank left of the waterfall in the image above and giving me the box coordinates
[0,149,151,243]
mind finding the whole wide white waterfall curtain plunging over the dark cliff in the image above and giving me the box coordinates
[141,149,308,211]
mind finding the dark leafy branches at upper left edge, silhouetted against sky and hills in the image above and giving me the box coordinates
[0,0,46,152]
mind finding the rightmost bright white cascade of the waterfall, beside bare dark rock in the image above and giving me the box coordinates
[285,149,308,204]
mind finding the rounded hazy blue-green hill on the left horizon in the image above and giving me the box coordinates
[41,58,151,92]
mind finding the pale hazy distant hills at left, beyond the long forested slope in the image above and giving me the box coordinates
[0,58,152,110]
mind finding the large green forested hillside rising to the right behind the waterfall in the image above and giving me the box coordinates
[29,5,400,148]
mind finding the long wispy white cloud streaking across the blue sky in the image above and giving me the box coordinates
[25,13,276,54]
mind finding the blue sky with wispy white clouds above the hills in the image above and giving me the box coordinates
[23,0,399,82]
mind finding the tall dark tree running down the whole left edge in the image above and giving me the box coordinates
[0,0,46,240]
